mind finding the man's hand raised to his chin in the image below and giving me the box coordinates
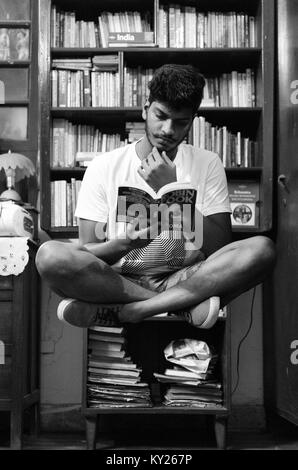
[138,147,177,193]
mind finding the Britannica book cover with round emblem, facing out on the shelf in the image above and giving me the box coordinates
[228,181,260,229]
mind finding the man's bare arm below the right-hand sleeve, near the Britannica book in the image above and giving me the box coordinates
[201,212,232,258]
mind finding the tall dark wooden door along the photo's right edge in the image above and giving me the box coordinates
[264,0,298,424]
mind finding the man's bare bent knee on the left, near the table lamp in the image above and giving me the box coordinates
[35,240,71,279]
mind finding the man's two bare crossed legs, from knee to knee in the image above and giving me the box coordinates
[37,237,275,328]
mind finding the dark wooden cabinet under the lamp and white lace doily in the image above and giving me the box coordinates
[0,241,40,449]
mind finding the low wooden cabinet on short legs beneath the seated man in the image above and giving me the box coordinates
[82,309,231,449]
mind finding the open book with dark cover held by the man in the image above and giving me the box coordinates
[116,182,197,238]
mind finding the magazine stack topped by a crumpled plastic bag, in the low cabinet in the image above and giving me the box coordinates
[154,338,222,408]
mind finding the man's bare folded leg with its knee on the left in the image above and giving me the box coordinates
[36,241,157,304]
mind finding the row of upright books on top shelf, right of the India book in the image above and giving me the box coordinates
[158,4,256,48]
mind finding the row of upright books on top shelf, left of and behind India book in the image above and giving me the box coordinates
[51,5,153,47]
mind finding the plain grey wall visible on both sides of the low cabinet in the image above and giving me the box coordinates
[37,234,264,428]
